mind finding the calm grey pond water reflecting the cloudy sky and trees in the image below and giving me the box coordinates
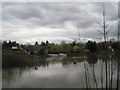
[2,54,117,88]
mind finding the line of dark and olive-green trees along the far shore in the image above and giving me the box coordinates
[2,40,120,53]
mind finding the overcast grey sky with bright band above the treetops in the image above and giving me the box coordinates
[0,2,118,44]
